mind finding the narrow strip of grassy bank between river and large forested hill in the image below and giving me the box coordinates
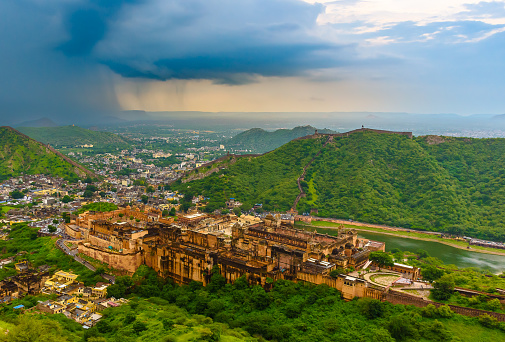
[297,221,505,256]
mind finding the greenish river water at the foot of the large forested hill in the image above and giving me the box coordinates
[317,228,505,274]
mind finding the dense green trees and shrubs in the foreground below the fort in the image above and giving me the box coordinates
[5,267,505,342]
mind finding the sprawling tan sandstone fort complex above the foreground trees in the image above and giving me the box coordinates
[66,207,382,291]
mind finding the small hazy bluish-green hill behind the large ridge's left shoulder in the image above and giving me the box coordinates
[224,126,335,153]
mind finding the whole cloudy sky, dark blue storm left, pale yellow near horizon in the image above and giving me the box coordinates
[0,0,505,123]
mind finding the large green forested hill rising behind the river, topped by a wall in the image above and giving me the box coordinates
[174,131,505,241]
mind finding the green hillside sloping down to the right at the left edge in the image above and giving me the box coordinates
[0,126,94,181]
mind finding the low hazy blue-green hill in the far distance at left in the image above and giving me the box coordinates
[18,126,130,150]
